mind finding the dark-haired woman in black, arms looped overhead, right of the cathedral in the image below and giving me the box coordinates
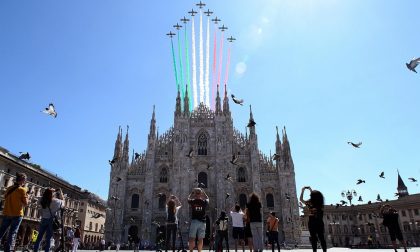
[300,186,327,252]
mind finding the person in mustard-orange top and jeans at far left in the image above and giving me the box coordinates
[0,173,29,252]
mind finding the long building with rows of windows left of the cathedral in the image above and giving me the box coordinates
[0,147,105,247]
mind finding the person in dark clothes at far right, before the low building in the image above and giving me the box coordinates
[381,204,407,252]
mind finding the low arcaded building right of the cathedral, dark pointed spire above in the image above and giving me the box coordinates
[303,174,420,247]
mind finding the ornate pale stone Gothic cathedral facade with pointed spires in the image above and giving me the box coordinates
[105,87,301,244]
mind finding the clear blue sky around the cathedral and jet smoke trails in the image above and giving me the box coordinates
[0,0,420,204]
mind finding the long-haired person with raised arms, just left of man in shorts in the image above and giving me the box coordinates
[165,195,182,252]
